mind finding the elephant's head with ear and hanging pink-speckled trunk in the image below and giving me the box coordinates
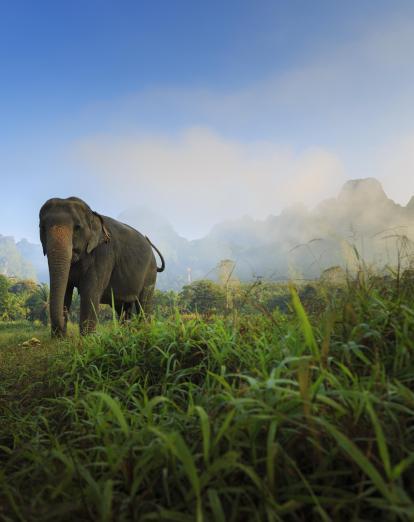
[39,197,109,335]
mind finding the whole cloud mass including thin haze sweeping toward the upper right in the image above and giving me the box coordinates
[68,13,414,236]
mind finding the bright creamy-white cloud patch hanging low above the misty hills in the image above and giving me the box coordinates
[77,128,344,236]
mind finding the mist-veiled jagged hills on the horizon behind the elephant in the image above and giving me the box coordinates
[0,178,414,289]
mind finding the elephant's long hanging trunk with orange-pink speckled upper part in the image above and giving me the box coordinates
[46,225,72,337]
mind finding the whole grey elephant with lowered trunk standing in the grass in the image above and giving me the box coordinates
[39,197,165,337]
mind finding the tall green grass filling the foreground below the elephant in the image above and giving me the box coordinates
[0,277,414,522]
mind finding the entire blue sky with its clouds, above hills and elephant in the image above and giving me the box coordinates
[0,0,414,240]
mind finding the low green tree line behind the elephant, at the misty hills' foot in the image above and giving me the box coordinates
[0,275,334,326]
